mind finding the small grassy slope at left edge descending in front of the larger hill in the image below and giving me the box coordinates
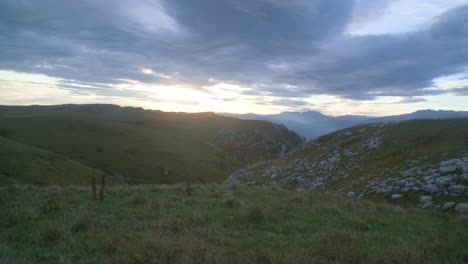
[0,137,102,185]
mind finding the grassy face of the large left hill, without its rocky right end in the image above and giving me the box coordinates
[0,108,300,183]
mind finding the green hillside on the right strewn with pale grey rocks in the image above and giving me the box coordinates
[225,118,468,213]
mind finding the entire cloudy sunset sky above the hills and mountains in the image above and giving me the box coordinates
[0,0,468,116]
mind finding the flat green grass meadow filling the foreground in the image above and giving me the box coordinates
[0,185,468,263]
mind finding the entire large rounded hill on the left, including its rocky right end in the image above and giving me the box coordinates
[0,105,302,184]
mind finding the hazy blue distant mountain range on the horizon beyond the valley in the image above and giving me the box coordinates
[220,110,468,140]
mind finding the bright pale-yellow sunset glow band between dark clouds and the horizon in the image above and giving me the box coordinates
[0,68,468,116]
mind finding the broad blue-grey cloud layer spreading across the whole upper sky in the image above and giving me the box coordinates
[0,0,468,106]
